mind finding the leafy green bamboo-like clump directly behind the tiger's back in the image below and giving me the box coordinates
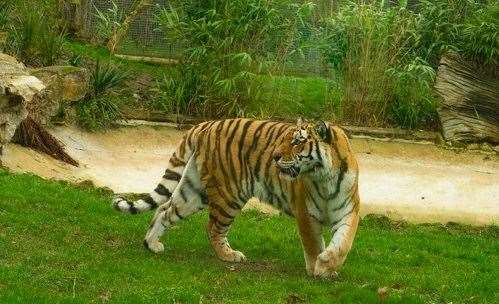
[157,0,313,116]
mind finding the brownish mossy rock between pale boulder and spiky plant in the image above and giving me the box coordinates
[30,66,90,103]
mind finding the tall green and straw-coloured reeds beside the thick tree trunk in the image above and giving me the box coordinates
[322,0,498,128]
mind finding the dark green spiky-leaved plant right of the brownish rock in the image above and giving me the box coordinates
[77,60,128,131]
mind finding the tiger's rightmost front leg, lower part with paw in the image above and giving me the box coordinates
[314,211,359,278]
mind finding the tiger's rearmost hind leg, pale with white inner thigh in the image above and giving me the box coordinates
[144,157,207,253]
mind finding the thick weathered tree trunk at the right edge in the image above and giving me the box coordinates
[435,53,499,144]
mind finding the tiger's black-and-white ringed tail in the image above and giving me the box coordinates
[112,138,193,214]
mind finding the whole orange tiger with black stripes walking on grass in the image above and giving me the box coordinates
[113,118,360,277]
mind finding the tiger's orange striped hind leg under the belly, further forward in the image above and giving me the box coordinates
[208,192,246,262]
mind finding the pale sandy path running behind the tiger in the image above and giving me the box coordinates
[2,126,499,225]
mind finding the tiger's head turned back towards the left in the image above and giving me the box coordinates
[272,119,334,179]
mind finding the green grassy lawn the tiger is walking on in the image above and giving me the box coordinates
[0,169,499,303]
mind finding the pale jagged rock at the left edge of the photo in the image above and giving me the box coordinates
[0,53,45,146]
